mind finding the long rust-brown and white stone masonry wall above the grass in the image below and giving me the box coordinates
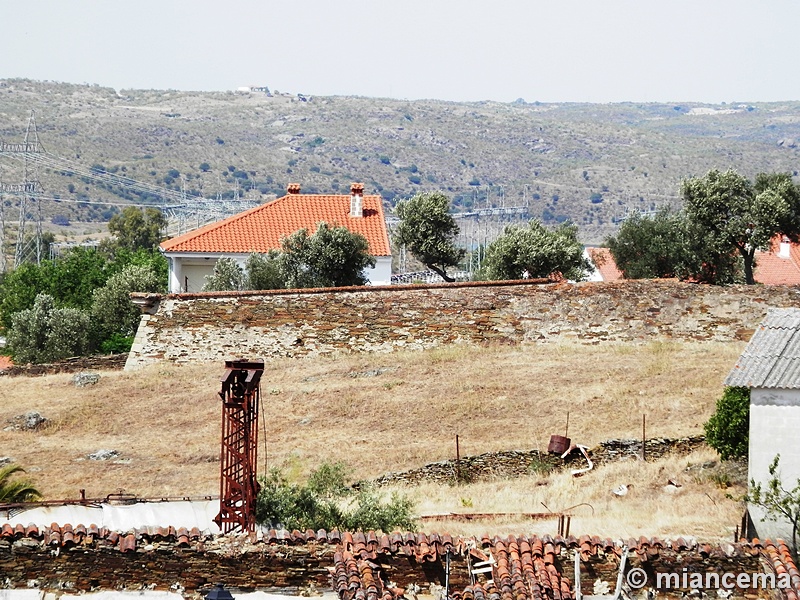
[126,280,800,368]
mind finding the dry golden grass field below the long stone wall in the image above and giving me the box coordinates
[0,343,742,538]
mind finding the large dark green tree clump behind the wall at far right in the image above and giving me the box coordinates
[606,170,800,285]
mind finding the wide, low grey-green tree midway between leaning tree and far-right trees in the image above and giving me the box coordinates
[482,219,592,280]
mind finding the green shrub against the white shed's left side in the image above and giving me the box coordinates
[705,387,750,460]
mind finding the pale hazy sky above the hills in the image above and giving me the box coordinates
[0,0,800,103]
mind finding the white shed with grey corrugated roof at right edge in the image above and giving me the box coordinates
[725,308,800,545]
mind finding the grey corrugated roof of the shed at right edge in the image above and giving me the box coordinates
[725,308,800,389]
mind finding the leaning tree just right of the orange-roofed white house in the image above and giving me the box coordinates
[394,192,466,281]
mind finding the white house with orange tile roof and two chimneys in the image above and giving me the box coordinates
[160,183,392,293]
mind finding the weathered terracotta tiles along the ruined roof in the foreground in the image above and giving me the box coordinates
[6,523,800,600]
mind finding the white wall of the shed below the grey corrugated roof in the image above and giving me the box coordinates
[748,388,800,545]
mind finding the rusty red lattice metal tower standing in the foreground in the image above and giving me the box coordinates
[214,360,264,533]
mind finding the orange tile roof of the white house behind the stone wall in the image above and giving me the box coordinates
[161,184,392,256]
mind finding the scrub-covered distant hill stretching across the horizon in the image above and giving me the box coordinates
[0,79,800,243]
